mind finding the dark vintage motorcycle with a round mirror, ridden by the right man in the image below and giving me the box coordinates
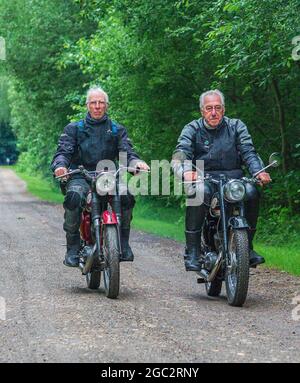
[173,153,280,306]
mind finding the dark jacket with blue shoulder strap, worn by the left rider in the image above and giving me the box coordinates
[51,113,139,171]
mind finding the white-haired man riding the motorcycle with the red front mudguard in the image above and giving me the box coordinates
[51,87,149,267]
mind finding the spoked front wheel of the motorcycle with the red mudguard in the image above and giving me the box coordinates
[103,225,120,299]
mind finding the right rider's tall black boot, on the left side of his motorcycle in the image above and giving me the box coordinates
[184,230,200,271]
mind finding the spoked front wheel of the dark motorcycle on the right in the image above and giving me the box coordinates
[225,229,249,306]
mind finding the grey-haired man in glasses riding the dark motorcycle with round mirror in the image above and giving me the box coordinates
[172,89,271,271]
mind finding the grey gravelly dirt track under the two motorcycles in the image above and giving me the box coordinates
[0,169,300,362]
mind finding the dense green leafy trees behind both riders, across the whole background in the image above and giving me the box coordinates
[0,0,300,222]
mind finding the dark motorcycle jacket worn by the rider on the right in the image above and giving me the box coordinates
[175,116,264,177]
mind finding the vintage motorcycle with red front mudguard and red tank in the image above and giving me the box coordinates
[56,162,142,299]
